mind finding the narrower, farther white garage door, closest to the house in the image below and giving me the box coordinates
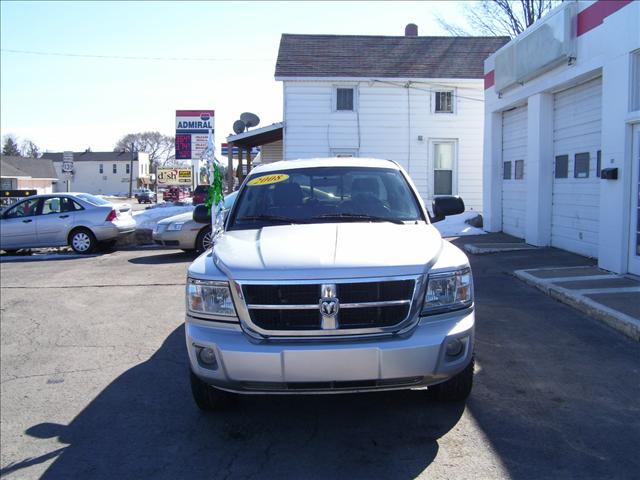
[502,105,527,238]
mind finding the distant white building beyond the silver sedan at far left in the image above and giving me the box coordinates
[42,152,150,195]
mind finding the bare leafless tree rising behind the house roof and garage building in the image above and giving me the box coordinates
[435,0,561,38]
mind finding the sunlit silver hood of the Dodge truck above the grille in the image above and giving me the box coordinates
[202,223,443,280]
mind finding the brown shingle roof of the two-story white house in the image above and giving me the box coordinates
[275,33,510,78]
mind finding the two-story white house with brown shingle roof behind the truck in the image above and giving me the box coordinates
[275,24,509,210]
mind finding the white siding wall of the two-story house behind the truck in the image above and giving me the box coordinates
[284,79,483,211]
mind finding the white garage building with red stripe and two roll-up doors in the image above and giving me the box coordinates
[484,0,640,274]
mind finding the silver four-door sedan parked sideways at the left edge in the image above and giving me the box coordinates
[0,193,136,253]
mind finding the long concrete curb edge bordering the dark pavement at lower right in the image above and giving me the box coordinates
[513,270,640,342]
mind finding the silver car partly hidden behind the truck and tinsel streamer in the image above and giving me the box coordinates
[152,192,237,253]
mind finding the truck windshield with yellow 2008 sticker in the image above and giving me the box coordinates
[228,167,425,230]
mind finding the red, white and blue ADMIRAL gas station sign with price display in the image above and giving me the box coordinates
[176,110,215,160]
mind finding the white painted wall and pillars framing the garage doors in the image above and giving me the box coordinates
[483,1,640,273]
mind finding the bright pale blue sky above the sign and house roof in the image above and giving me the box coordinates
[0,0,468,151]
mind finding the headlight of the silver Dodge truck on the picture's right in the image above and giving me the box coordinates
[422,267,473,315]
